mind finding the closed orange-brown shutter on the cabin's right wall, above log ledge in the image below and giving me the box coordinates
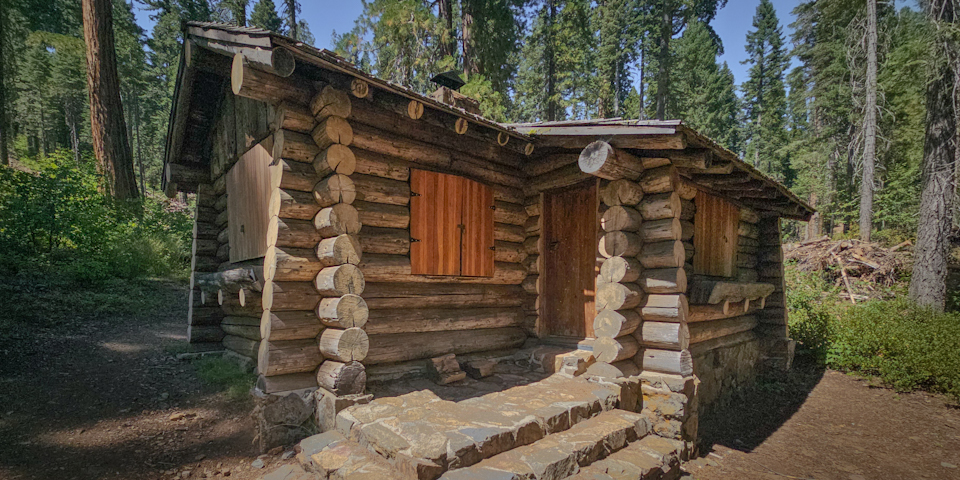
[693,191,740,277]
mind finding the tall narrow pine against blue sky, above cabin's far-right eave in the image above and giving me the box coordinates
[741,0,789,181]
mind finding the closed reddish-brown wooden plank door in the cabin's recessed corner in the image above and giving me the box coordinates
[540,179,599,339]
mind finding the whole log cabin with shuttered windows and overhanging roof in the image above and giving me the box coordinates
[163,23,813,440]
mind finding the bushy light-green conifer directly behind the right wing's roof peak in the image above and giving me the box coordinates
[667,21,739,150]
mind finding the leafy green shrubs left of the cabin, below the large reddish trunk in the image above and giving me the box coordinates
[0,151,191,283]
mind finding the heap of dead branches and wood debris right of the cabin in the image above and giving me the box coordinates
[783,237,911,286]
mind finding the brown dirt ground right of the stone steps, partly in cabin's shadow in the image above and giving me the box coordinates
[687,371,960,480]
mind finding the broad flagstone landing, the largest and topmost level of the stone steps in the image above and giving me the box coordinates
[337,376,619,480]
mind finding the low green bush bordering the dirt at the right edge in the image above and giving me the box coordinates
[827,300,960,399]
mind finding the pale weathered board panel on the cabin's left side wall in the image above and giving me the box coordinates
[226,144,273,262]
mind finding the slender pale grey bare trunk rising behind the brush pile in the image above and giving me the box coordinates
[860,0,877,242]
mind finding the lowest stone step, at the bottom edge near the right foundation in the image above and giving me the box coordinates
[567,435,686,480]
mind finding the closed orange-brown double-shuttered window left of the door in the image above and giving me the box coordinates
[410,170,494,277]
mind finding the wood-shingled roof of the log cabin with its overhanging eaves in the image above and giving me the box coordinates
[163,22,814,220]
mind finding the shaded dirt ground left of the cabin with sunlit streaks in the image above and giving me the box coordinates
[0,283,271,480]
